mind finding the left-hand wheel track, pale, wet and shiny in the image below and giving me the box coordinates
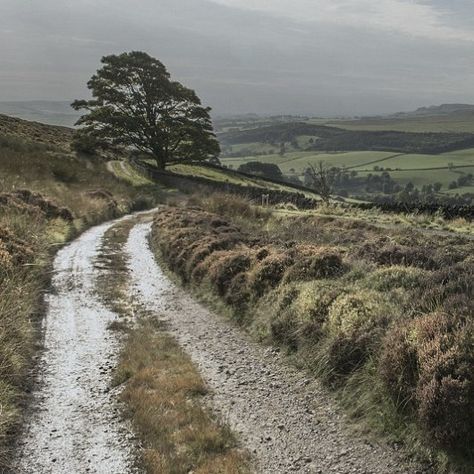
[13,219,134,474]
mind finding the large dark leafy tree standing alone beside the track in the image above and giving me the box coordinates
[71,51,220,169]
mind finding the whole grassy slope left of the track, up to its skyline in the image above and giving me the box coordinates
[0,116,163,470]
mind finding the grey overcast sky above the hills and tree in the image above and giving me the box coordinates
[0,0,474,115]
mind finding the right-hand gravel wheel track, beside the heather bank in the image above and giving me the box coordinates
[126,223,422,474]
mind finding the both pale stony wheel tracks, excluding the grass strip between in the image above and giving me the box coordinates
[13,214,422,474]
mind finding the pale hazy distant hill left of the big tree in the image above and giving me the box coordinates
[0,100,80,127]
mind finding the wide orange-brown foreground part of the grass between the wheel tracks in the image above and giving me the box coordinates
[116,322,248,474]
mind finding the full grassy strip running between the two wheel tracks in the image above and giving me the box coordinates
[99,222,249,474]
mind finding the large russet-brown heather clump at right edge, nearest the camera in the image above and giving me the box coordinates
[380,313,474,450]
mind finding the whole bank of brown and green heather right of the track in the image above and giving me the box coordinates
[152,196,474,472]
